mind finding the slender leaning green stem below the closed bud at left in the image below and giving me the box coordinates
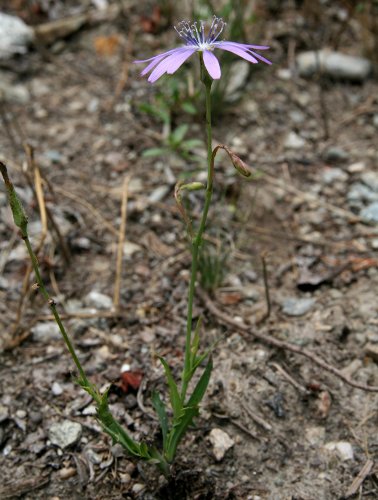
[22,234,101,403]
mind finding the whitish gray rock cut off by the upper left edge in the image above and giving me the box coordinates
[0,12,34,59]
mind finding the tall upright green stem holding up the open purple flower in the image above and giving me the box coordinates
[181,56,213,403]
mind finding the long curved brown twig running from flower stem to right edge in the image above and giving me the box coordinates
[198,290,378,392]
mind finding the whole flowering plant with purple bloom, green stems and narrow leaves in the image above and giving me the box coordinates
[0,17,270,475]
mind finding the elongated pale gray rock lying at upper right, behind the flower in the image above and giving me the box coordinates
[297,49,372,82]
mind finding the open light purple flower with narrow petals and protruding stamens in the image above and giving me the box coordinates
[134,16,272,83]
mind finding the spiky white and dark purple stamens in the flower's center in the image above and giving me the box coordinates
[175,16,226,50]
